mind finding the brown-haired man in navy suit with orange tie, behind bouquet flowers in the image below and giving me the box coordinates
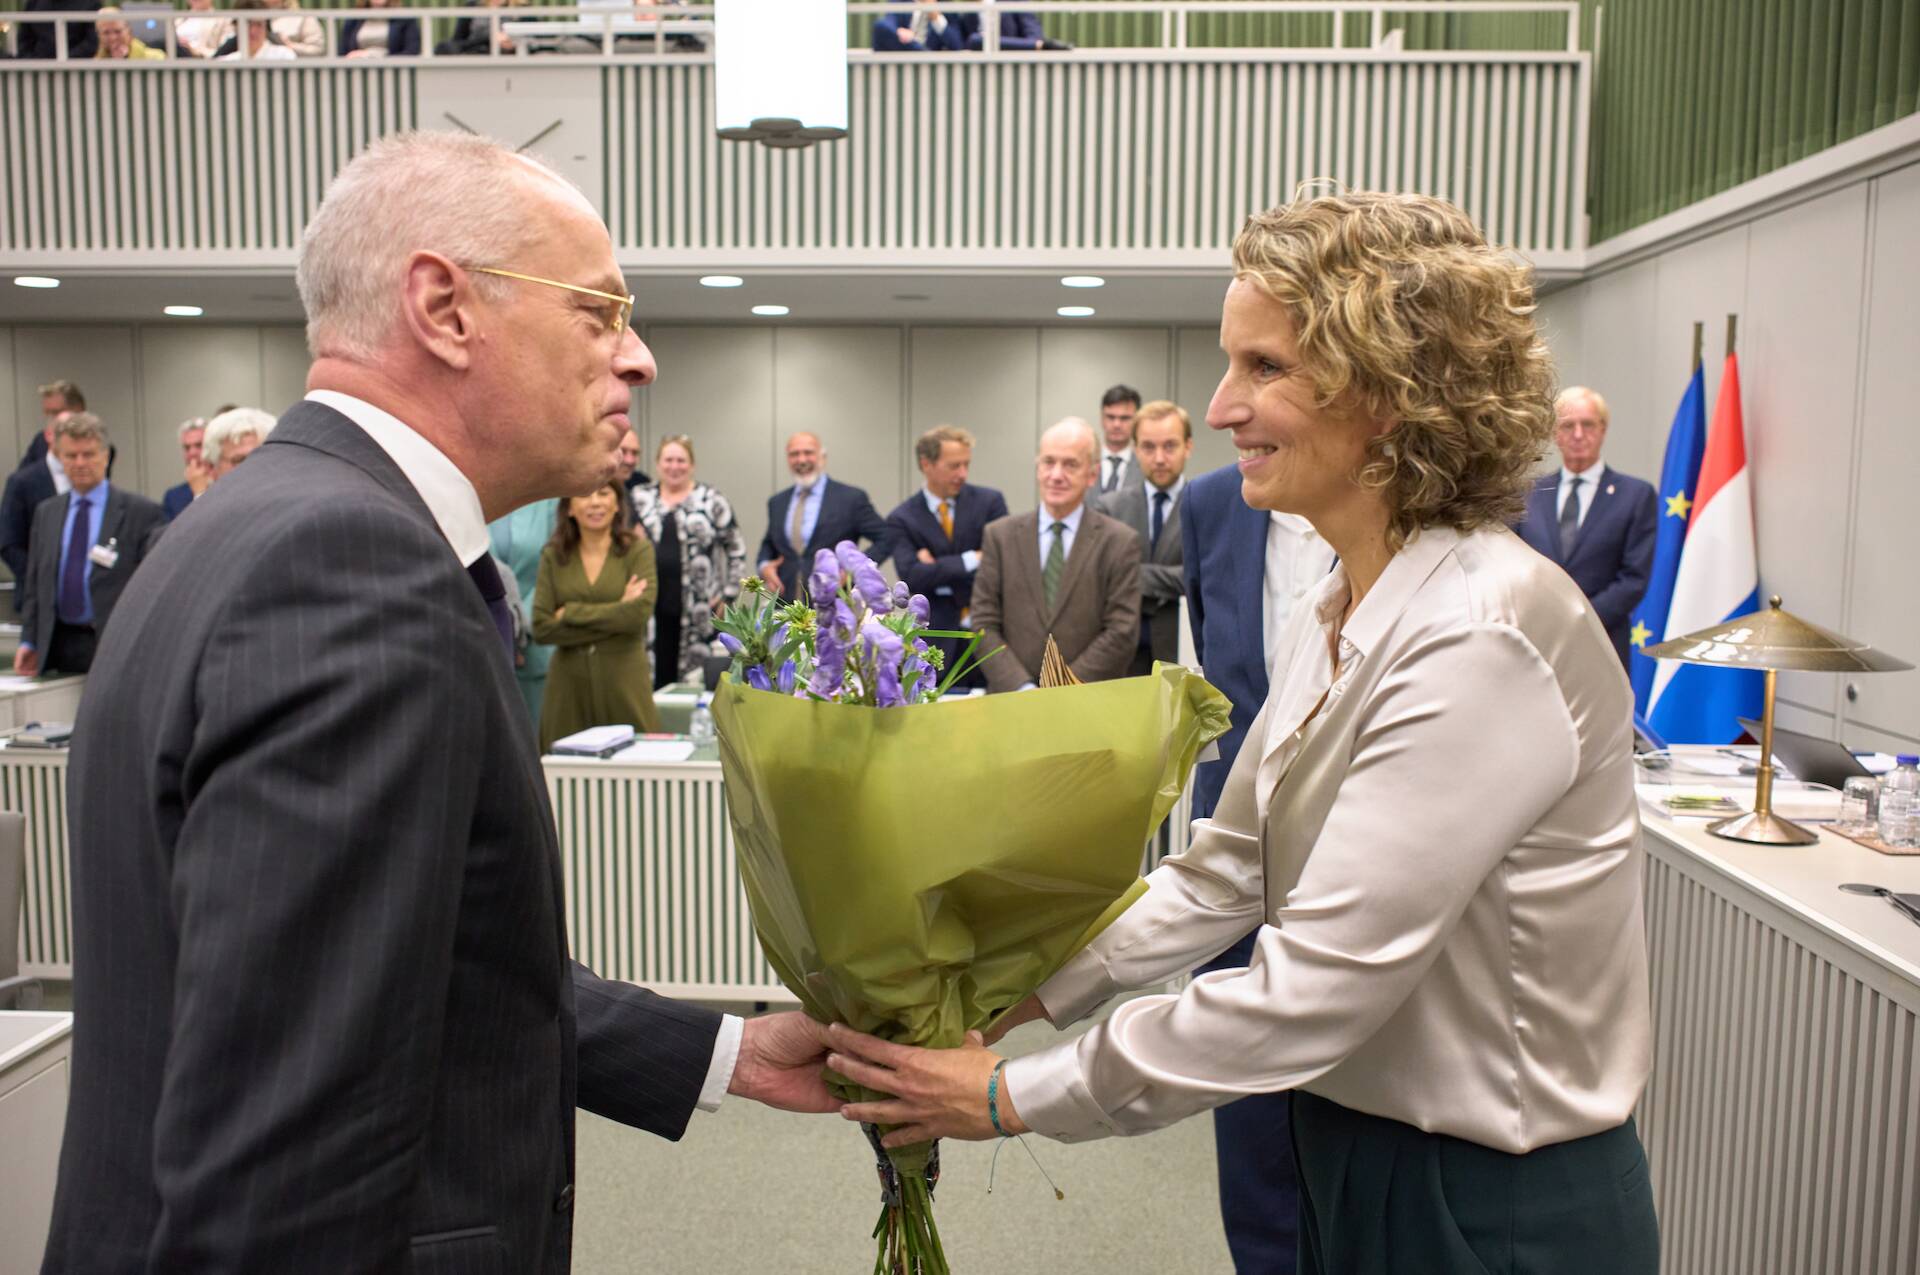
[887,424,1006,686]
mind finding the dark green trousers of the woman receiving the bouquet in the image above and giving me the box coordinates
[1292,1091,1661,1275]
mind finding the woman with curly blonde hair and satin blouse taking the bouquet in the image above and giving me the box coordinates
[829,192,1659,1275]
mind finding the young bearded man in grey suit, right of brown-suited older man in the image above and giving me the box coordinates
[1104,399,1194,676]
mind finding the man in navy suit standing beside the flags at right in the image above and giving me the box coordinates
[1519,386,1659,668]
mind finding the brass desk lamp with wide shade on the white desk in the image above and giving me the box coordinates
[1642,595,1912,845]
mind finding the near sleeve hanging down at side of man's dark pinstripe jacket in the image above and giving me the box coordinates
[148,507,499,1273]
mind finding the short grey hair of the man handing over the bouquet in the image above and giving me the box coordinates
[296,132,570,363]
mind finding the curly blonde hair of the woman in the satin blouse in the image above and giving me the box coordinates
[1233,188,1553,551]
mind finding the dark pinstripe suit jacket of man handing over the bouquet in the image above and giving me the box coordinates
[46,403,718,1275]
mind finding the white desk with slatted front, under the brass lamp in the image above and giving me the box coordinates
[1638,814,1920,1275]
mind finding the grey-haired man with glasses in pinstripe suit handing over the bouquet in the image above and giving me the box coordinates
[46,132,835,1275]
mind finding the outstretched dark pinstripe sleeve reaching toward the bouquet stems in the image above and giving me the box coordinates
[572,962,720,1141]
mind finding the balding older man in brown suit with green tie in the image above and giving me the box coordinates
[972,417,1140,691]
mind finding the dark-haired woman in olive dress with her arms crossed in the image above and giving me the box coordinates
[534,482,659,753]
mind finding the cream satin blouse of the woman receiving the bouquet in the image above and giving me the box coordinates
[1006,528,1651,1152]
